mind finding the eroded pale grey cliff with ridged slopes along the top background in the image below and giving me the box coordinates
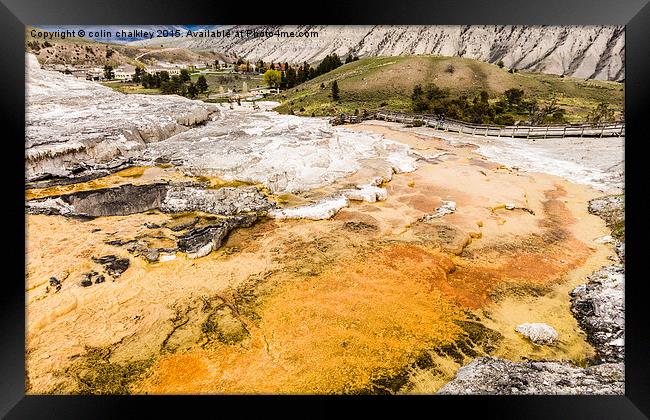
[134,25,625,81]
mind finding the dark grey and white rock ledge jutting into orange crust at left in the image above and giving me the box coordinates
[26,179,275,258]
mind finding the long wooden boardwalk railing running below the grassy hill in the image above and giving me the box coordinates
[330,111,625,139]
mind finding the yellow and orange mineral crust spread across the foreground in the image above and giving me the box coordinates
[26,120,613,394]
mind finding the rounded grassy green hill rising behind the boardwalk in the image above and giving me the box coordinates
[274,56,624,121]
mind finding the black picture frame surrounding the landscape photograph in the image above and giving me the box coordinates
[0,0,650,419]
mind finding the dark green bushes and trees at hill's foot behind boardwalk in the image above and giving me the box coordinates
[411,84,566,125]
